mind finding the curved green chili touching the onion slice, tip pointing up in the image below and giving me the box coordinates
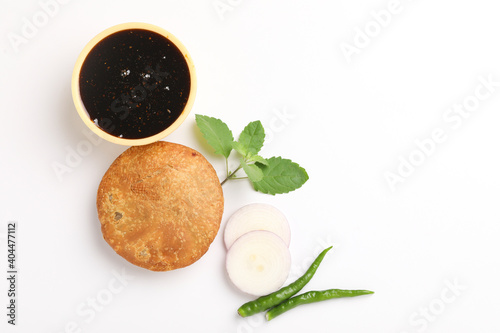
[238,246,332,317]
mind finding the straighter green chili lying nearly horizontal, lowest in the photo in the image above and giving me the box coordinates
[266,289,373,320]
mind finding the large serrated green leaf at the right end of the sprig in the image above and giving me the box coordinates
[254,157,309,195]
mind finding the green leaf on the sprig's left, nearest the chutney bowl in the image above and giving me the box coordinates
[196,114,234,158]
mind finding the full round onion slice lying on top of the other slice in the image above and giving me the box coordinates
[226,230,291,296]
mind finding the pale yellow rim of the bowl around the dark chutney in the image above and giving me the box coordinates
[71,22,197,146]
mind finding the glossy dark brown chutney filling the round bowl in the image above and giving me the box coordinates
[79,29,191,139]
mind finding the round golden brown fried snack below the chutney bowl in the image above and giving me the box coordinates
[97,141,224,271]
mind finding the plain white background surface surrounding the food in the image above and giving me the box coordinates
[0,0,500,333]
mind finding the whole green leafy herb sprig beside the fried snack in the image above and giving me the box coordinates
[196,115,309,195]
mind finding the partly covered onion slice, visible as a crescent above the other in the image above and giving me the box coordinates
[224,203,290,249]
